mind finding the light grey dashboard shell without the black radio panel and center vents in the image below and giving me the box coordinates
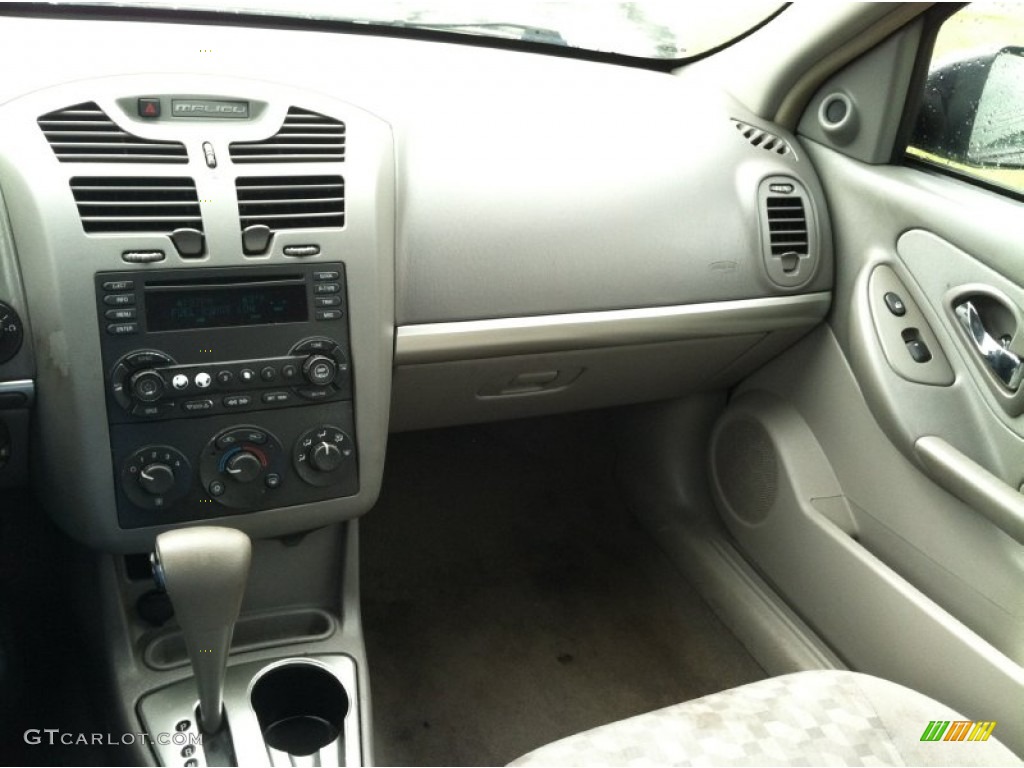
[0,15,833,551]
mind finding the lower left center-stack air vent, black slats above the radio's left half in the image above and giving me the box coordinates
[71,176,203,234]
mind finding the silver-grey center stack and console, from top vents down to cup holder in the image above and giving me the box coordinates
[0,74,395,766]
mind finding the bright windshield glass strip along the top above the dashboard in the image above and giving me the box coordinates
[46,0,783,58]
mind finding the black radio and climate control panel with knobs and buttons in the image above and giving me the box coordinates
[95,262,359,528]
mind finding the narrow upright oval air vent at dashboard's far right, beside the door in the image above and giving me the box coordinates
[758,176,818,288]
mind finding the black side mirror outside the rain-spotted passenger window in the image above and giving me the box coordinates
[913,46,1024,169]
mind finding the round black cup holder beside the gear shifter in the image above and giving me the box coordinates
[251,662,349,757]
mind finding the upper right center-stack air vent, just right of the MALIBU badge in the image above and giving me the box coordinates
[229,106,345,163]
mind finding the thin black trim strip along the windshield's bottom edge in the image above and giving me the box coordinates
[0,2,791,73]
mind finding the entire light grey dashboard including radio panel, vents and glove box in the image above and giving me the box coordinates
[0,10,833,552]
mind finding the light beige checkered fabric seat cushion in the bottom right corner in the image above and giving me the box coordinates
[511,671,1022,767]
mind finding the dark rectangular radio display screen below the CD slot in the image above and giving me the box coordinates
[145,283,309,332]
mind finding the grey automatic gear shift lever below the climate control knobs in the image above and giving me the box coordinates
[153,526,252,733]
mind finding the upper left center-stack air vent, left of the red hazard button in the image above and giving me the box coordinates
[36,101,188,163]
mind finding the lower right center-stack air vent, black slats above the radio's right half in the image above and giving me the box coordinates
[236,176,345,231]
